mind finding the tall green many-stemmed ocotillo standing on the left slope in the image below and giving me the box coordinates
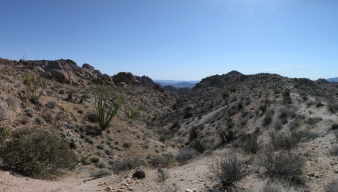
[94,86,120,130]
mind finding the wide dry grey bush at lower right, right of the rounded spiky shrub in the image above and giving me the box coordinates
[261,148,305,184]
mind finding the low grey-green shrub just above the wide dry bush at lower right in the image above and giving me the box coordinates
[270,131,300,150]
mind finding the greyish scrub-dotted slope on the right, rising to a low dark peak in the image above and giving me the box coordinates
[162,71,338,151]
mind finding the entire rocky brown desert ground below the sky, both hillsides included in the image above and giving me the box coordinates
[0,59,338,192]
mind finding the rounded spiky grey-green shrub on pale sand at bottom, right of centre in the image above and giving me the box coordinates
[211,155,246,191]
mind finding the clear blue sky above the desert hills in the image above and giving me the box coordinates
[0,0,338,80]
